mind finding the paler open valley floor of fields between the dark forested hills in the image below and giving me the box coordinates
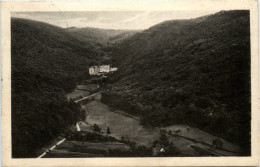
[39,85,241,158]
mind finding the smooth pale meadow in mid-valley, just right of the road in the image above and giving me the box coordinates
[84,94,160,146]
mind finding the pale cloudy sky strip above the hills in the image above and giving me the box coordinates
[12,10,218,29]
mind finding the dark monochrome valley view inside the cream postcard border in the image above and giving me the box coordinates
[2,0,258,166]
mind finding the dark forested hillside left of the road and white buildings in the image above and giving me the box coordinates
[11,18,97,157]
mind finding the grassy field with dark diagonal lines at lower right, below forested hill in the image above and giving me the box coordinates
[163,125,241,156]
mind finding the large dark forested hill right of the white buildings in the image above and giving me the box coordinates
[102,11,251,153]
